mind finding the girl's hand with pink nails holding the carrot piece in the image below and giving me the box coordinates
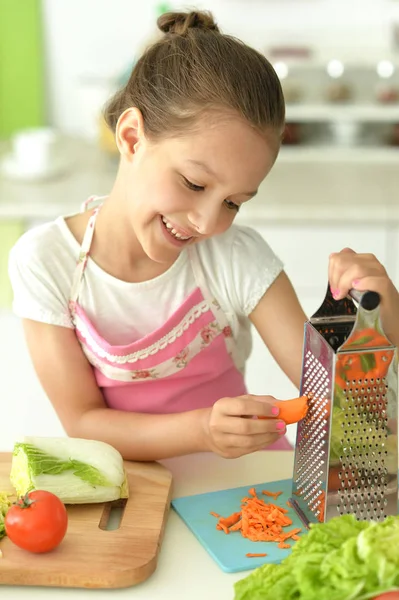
[204,395,286,458]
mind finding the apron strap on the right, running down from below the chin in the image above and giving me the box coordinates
[188,244,239,368]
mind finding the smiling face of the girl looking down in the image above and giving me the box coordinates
[120,111,279,263]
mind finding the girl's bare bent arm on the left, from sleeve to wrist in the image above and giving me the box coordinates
[23,320,203,460]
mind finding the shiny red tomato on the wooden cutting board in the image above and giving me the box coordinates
[4,490,68,553]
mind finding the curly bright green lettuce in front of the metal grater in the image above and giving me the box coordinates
[234,515,399,600]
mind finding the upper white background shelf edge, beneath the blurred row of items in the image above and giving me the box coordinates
[286,103,399,123]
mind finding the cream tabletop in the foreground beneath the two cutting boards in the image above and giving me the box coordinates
[0,443,293,600]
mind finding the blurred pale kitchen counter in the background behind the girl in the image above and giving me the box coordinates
[0,139,399,224]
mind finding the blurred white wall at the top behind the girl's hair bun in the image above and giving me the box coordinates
[43,0,399,134]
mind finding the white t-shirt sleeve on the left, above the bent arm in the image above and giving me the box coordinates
[8,225,73,328]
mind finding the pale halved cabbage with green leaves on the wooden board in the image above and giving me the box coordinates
[10,437,128,504]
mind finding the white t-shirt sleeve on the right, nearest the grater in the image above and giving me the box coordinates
[231,226,284,316]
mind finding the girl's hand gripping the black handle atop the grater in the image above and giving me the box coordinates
[328,248,399,346]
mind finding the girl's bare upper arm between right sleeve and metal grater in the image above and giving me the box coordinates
[249,271,307,389]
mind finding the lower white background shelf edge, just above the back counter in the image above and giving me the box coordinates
[277,145,399,166]
